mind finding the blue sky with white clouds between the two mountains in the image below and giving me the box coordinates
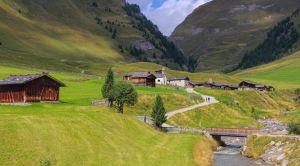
[127,0,211,36]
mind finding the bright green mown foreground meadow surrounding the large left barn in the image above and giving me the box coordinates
[0,67,218,165]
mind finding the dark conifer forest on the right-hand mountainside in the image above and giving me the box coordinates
[238,13,299,69]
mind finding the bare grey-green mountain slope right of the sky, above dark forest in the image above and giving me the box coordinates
[171,0,300,71]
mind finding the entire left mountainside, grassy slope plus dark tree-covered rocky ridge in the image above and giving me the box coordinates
[0,0,187,73]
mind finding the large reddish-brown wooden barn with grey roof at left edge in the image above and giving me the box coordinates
[0,73,65,103]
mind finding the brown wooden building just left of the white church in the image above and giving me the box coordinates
[123,72,156,87]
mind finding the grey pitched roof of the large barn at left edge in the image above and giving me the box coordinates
[0,73,65,86]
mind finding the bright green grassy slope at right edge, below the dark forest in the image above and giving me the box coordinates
[235,52,300,89]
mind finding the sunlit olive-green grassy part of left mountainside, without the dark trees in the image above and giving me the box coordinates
[0,0,126,72]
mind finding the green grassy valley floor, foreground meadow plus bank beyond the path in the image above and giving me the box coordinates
[0,66,299,166]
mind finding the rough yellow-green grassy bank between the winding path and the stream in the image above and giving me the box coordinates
[170,88,296,128]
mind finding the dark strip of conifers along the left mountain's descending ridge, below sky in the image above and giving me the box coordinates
[123,3,188,70]
